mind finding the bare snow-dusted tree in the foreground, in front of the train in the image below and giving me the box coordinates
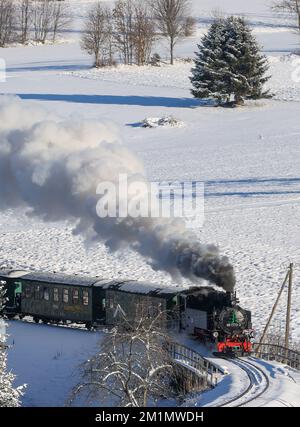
[71,307,176,407]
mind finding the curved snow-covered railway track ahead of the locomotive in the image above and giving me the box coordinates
[220,358,270,407]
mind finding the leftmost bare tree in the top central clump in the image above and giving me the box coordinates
[81,2,113,67]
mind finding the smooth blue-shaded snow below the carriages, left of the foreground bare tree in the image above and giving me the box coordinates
[8,321,101,406]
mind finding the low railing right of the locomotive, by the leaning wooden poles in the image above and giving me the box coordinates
[252,343,300,370]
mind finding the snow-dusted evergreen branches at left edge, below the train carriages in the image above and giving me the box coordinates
[0,282,23,408]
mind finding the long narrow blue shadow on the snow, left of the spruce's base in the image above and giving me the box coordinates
[17,93,212,108]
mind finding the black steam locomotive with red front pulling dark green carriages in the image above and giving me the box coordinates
[0,269,252,355]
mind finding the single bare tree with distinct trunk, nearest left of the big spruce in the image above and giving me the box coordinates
[150,0,195,64]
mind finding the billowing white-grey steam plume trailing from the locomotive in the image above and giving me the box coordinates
[0,97,235,291]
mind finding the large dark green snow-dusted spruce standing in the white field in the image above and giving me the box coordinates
[191,16,271,105]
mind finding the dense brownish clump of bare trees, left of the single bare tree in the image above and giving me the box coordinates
[81,0,155,66]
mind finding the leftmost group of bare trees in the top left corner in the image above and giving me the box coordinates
[0,0,72,47]
